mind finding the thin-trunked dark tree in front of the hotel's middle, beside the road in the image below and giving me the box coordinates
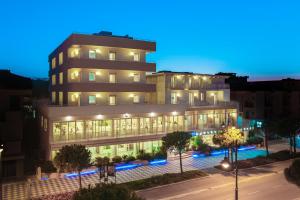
[162,131,192,174]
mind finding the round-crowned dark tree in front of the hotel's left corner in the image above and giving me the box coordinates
[54,144,91,189]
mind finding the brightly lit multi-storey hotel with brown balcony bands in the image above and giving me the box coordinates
[39,32,238,159]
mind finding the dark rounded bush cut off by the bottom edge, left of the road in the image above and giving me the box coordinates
[73,184,142,200]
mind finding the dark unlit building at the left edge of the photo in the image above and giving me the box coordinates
[0,70,32,177]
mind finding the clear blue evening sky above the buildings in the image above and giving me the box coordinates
[0,0,300,79]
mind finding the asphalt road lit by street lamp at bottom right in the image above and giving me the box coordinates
[138,162,300,200]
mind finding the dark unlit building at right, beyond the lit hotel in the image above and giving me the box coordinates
[221,73,300,120]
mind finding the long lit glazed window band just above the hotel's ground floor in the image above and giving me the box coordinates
[50,110,237,143]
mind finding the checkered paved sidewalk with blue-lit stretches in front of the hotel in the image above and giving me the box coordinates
[3,149,265,199]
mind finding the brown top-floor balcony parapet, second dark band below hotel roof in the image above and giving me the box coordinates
[53,58,156,72]
